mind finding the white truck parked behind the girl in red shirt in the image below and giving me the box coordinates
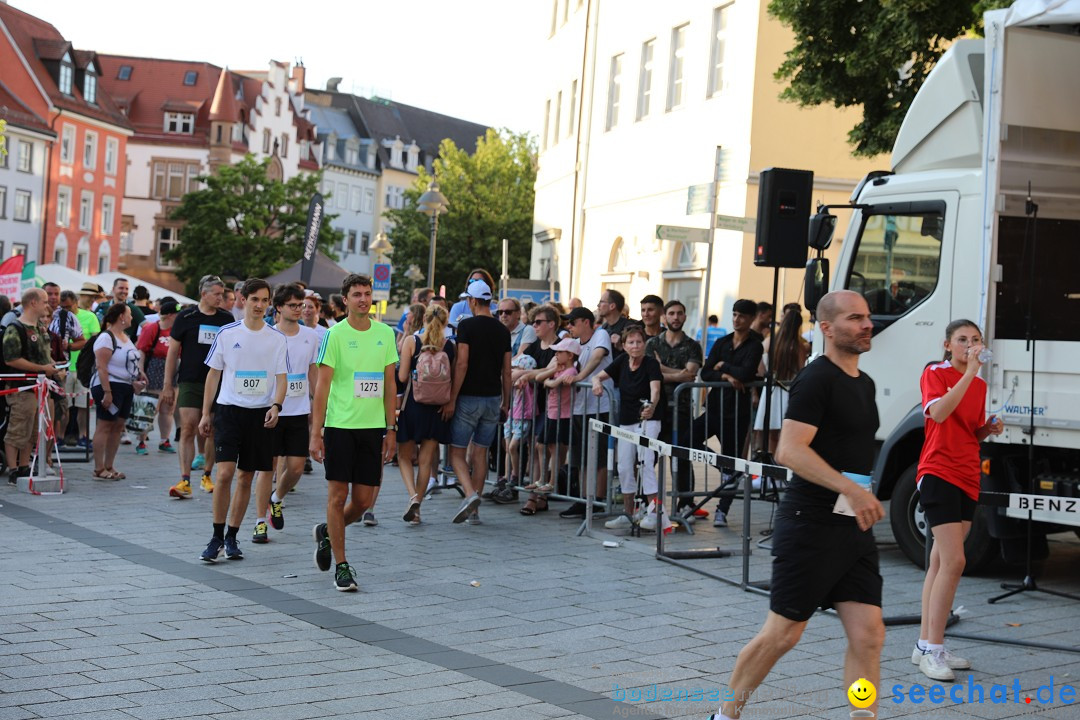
[808,0,1080,570]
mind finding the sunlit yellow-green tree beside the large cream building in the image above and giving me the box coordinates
[384,130,537,303]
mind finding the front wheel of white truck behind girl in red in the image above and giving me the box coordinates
[889,464,999,575]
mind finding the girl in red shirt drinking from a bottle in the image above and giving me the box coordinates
[912,320,1003,681]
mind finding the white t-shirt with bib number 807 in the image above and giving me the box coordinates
[206,322,288,408]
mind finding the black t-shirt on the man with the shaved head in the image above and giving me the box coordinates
[781,355,878,525]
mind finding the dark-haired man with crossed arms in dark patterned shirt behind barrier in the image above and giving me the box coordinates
[645,300,702,515]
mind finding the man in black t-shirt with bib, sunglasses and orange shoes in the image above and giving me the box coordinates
[161,275,234,499]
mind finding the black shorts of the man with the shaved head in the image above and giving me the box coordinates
[769,514,881,623]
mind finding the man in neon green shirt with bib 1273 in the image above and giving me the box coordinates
[309,274,397,592]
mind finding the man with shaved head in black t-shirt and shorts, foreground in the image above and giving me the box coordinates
[713,290,885,720]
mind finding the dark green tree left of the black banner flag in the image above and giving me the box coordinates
[168,155,342,297]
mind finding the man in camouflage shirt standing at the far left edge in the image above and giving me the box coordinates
[3,288,60,485]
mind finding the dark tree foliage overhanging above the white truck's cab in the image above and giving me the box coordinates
[769,0,1012,157]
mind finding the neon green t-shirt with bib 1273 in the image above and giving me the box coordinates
[316,320,397,430]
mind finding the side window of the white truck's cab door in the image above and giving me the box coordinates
[847,208,945,317]
